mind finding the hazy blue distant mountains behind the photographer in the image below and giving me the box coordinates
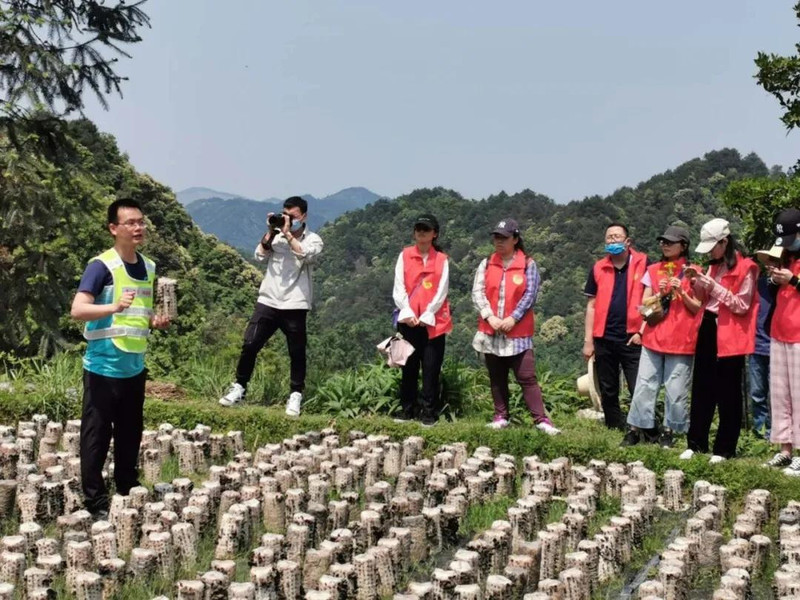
[181,187,380,250]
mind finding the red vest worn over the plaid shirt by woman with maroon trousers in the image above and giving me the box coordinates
[478,250,534,337]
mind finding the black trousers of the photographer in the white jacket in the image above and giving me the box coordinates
[236,302,308,392]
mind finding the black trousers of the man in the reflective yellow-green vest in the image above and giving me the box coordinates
[81,371,147,513]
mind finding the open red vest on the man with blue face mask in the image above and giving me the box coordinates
[592,248,647,337]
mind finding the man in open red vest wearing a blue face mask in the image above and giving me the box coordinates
[583,223,650,430]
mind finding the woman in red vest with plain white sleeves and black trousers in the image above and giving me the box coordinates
[392,214,453,426]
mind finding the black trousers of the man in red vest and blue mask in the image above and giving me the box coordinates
[594,338,642,429]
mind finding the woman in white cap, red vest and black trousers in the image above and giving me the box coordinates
[680,219,758,464]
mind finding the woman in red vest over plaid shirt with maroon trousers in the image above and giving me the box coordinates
[472,219,561,435]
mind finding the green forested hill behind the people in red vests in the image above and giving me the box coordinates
[311,149,768,370]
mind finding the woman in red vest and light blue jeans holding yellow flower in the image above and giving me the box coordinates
[622,226,703,448]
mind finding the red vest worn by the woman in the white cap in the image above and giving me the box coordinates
[709,252,758,358]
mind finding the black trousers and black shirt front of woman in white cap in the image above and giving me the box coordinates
[686,312,744,458]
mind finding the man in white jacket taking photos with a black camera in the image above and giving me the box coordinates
[219,196,322,417]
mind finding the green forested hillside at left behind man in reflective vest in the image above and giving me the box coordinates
[0,120,260,375]
